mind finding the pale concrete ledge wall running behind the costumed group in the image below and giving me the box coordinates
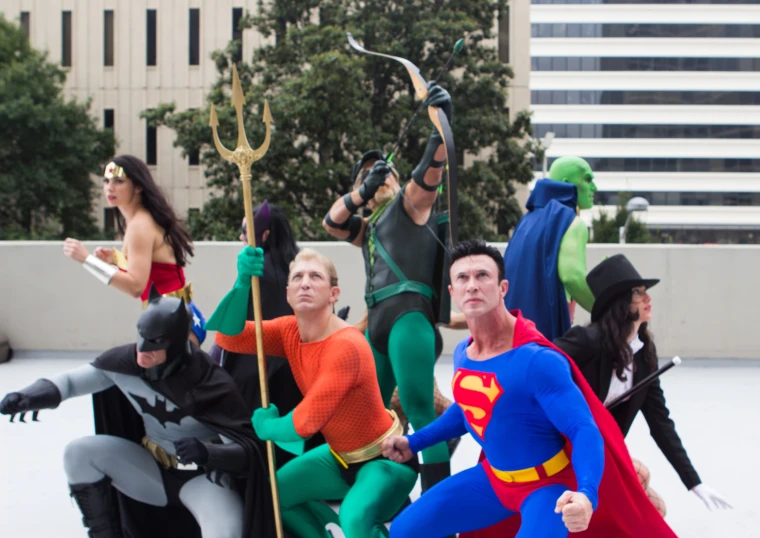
[0,241,760,359]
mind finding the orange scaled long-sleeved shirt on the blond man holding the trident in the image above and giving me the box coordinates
[216,316,393,452]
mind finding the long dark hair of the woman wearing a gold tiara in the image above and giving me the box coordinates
[113,155,194,267]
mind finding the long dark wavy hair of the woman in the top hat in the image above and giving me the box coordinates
[595,291,657,381]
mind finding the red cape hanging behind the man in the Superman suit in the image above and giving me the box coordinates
[459,311,676,538]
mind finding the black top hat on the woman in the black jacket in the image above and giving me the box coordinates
[586,254,660,322]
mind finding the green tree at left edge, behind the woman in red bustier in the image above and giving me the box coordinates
[0,14,115,240]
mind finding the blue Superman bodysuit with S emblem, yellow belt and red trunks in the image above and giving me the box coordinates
[391,340,604,538]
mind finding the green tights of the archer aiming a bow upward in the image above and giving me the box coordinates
[367,312,449,463]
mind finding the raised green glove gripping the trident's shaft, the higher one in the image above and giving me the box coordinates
[205,246,264,335]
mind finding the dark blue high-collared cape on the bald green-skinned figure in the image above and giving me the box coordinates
[504,179,578,341]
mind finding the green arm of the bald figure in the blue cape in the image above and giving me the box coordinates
[557,217,594,312]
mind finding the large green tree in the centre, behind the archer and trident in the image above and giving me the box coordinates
[143,0,533,240]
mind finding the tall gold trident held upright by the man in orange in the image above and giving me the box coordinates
[208,64,283,538]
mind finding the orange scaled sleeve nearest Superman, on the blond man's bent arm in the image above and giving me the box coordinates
[293,340,361,439]
